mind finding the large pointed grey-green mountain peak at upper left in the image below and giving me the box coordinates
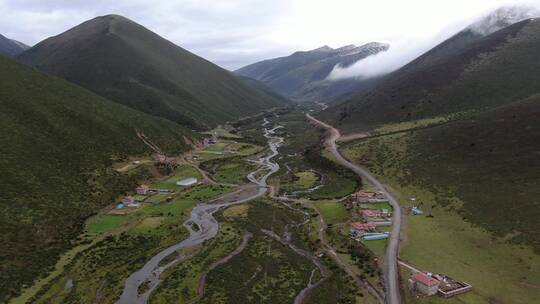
[18,15,283,128]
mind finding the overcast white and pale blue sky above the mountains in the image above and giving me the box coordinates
[0,0,540,69]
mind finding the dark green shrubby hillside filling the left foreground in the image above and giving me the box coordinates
[0,57,197,303]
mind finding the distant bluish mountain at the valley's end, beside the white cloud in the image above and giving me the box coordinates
[235,42,389,102]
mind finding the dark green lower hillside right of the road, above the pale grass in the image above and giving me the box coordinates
[345,95,540,252]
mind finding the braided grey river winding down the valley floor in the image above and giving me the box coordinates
[117,119,283,304]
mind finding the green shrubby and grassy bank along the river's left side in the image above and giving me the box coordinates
[32,186,230,303]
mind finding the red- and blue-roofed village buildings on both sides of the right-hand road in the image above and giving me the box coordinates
[343,191,472,298]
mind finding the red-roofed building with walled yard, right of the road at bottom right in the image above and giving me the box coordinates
[407,271,472,298]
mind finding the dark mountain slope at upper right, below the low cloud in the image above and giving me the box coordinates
[321,19,540,131]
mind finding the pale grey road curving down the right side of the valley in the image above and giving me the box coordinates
[306,114,401,304]
